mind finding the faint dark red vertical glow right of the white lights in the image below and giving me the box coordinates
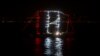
[65,15,74,49]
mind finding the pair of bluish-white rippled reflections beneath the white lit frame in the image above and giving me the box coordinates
[44,37,63,56]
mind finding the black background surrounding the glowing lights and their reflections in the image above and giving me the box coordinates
[0,0,100,56]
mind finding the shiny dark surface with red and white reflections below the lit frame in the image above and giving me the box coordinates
[33,37,73,56]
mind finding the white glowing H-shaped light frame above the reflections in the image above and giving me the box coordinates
[44,10,60,34]
